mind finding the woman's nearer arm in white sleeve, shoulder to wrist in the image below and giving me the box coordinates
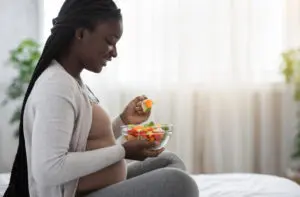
[32,84,125,186]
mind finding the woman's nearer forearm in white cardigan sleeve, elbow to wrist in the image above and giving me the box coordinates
[32,145,125,186]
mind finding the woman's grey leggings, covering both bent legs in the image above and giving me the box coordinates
[87,152,199,197]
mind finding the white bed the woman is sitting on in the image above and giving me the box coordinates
[0,174,300,197]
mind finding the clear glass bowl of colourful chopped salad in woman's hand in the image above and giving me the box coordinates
[121,122,173,150]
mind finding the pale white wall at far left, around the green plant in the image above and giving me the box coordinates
[0,0,42,173]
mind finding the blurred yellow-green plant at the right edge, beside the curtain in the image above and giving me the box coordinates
[281,49,300,183]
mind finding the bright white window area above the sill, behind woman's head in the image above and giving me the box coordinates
[44,0,286,86]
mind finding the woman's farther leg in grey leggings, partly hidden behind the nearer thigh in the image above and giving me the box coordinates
[127,151,186,179]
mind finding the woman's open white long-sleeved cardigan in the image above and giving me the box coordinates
[24,61,125,197]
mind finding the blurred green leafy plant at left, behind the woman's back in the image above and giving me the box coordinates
[2,39,41,135]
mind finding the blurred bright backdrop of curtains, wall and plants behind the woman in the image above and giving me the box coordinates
[0,0,300,179]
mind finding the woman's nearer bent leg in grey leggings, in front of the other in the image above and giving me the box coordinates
[87,168,199,197]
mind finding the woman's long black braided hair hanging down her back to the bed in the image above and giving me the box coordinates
[4,0,121,197]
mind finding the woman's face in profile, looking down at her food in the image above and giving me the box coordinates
[77,19,123,73]
